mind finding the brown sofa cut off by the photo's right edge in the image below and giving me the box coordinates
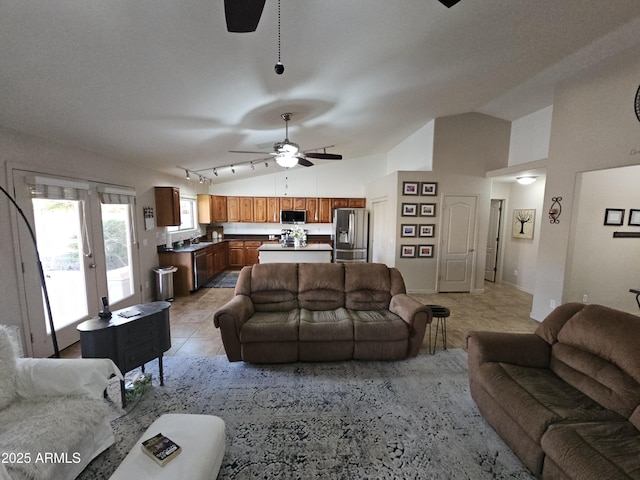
[467,303,640,480]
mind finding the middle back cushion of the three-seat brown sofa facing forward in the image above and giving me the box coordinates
[298,263,344,310]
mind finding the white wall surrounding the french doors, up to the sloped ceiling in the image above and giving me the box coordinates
[0,128,206,344]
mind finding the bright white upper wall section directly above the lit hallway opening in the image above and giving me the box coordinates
[509,105,553,166]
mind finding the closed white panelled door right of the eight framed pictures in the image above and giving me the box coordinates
[438,195,478,292]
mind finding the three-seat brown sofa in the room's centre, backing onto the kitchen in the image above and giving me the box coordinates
[213,263,431,363]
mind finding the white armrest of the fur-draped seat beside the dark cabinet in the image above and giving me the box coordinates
[16,358,124,399]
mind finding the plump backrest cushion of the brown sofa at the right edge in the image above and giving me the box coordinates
[550,305,640,418]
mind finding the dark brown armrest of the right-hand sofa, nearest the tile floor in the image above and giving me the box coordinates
[467,331,551,370]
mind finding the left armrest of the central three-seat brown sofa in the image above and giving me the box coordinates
[213,295,255,362]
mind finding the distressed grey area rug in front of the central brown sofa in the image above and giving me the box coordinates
[79,350,534,480]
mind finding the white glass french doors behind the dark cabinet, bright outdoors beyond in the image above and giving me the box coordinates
[13,170,140,357]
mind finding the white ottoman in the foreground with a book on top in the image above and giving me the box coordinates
[111,413,227,480]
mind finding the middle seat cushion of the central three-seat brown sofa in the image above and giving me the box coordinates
[299,308,353,342]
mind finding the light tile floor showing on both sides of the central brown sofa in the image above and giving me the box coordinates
[61,282,539,358]
